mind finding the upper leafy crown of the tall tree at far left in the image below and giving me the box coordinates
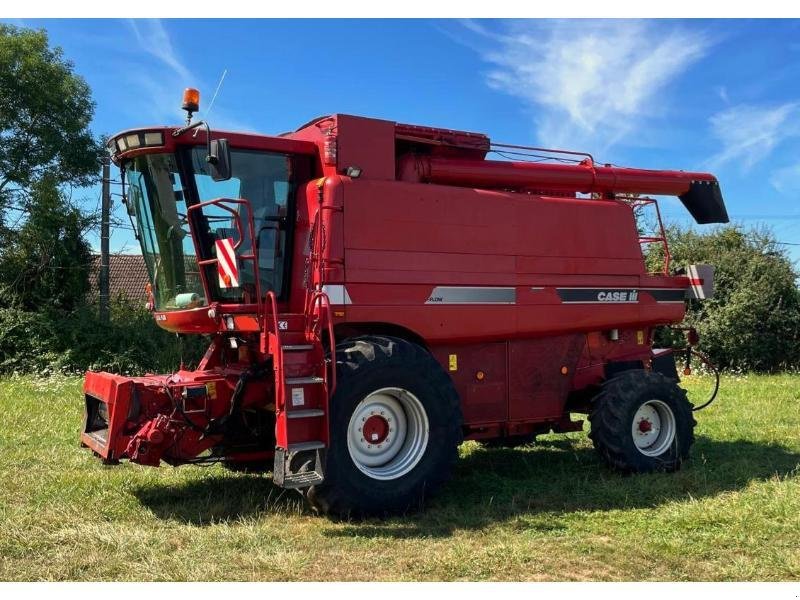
[0,23,101,219]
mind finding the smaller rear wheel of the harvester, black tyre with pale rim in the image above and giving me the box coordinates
[589,369,697,473]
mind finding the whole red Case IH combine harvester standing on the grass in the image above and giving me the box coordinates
[81,90,728,514]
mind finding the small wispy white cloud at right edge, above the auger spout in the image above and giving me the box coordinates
[708,102,800,171]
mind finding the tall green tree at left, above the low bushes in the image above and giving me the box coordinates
[0,24,102,310]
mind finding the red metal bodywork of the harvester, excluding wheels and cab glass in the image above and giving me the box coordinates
[83,115,717,464]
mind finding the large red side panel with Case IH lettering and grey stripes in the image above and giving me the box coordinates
[328,179,685,344]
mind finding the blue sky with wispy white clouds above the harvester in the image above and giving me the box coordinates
[6,20,800,259]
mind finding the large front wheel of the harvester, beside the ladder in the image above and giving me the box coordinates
[306,336,462,516]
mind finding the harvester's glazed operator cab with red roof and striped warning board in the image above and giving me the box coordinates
[108,104,316,332]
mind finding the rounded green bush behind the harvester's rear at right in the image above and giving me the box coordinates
[648,226,800,371]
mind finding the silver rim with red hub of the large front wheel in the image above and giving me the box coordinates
[347,387,430,480]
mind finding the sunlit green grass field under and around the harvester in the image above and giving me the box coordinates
[0,375,800,580]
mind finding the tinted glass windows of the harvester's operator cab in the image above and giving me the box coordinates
[126,146,310,310]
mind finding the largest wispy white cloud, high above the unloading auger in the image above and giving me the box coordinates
[470,20,711,154]
